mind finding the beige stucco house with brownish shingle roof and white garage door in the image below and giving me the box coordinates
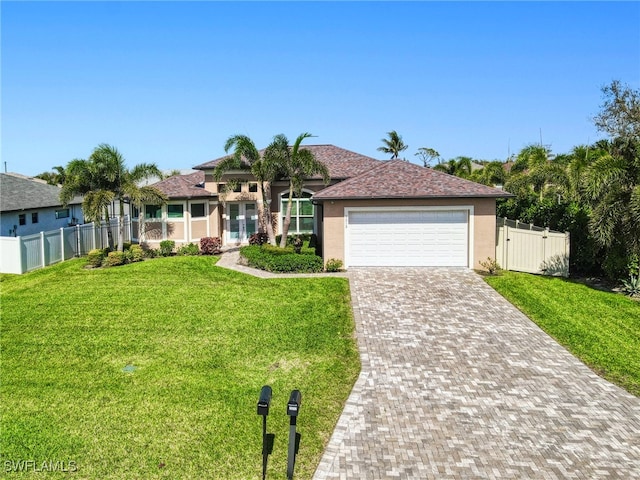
[142,145,509,268]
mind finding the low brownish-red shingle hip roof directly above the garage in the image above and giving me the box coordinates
[313,160,510,200]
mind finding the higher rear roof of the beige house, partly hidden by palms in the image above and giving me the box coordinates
[193,145,381,180]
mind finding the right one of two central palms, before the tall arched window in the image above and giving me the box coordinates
[264,133,330,248]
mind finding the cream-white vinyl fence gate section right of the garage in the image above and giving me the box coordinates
[496,218,569,277]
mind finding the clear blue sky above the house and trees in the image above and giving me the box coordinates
[0,1,640,175]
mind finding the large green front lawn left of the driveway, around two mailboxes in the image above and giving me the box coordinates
[0,257,359,480]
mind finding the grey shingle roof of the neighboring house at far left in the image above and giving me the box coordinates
[0,173,82,212]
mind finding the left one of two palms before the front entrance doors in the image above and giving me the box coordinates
[213,135,277,245]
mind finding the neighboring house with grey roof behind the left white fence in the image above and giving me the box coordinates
[0,173,84,237]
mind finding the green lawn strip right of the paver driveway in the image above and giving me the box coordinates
[485,272,640,396]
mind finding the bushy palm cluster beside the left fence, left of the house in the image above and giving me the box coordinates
[60,144,166,251]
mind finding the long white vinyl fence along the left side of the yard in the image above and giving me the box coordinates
[0,217,131,274]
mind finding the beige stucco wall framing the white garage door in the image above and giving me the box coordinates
[323,198,496,268]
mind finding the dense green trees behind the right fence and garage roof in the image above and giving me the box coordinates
[379,80,640,280]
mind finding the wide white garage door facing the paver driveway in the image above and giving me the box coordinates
[345,210,469,267]
